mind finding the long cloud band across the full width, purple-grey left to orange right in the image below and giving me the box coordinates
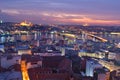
[0,9,120,25]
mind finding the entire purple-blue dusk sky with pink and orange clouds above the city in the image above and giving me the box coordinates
[0,0,120,25]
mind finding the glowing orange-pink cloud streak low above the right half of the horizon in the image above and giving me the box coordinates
[57,18,120,25]
